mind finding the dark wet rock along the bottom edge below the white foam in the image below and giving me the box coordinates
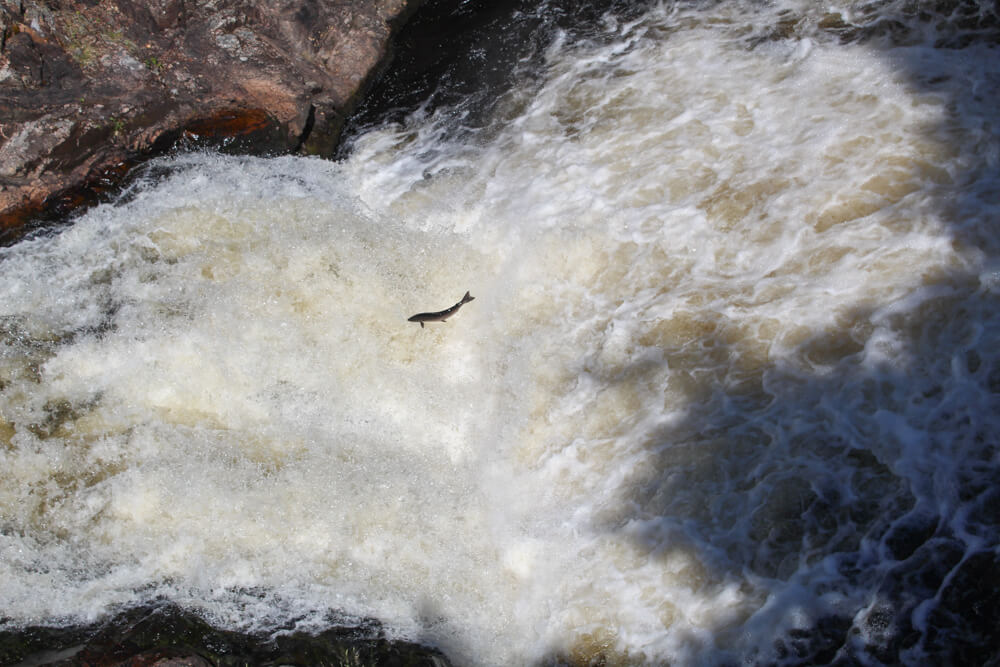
[0,603,449,667]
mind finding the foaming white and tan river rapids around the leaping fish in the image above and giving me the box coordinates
[0,0,1000,665]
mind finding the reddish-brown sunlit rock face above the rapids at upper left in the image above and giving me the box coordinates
[0,0,421,239]
